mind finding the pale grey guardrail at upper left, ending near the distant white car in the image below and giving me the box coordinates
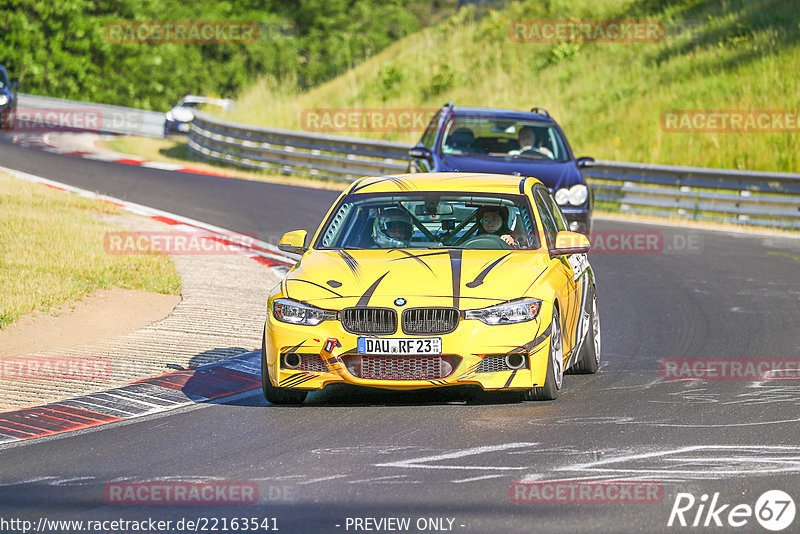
[17,93,165,138]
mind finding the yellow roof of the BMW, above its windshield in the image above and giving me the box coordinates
[348,172,540,194]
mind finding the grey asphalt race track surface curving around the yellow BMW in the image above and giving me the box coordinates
[0,141,800,533]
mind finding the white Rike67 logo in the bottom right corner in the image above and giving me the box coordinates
[667,490,797,532]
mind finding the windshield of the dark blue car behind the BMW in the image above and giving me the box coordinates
[442,116,569,161]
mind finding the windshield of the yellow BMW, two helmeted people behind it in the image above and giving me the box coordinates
[316,192,539,250]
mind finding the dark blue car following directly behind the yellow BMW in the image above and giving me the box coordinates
[408,102,594,234]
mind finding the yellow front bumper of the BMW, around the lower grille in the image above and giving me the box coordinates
[265,310,552,390]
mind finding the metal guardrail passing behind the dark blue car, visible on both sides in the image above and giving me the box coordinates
[189,113,800,229]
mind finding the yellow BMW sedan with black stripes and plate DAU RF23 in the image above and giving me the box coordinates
[261,173,600,404]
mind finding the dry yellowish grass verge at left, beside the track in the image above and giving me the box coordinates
[0,173,181,329]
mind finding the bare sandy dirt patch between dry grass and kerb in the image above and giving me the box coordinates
[0,288,181,357]
